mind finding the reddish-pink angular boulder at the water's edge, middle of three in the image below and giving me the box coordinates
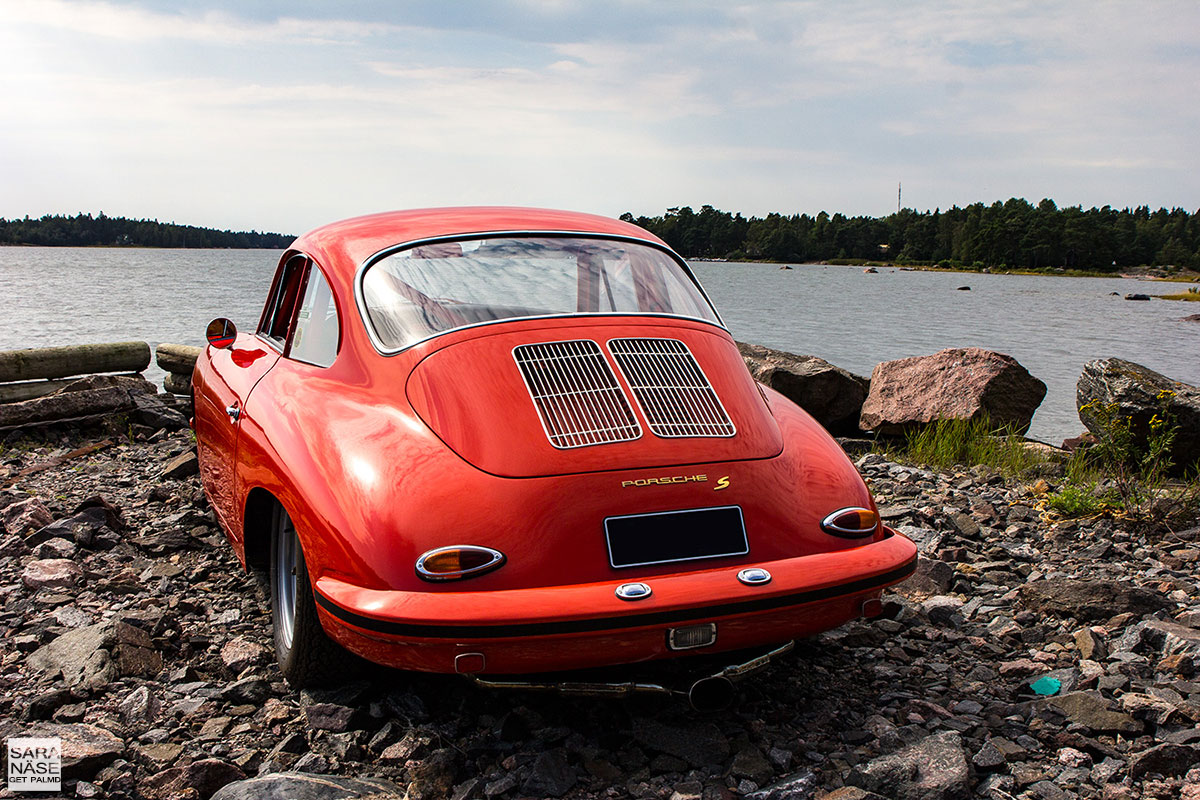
[859,348,1046,434]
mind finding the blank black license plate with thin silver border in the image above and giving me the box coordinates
[604,506,750,567]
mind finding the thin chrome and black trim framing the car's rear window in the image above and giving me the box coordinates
[354,230,730,356]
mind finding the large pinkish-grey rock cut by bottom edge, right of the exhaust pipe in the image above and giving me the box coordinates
[846,732,970,800]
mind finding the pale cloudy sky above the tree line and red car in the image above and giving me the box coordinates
[0,0,1200,234]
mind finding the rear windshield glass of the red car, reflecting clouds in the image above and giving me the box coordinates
[362,236,720,350]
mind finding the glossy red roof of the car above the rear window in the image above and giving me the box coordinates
[289,206,666,281]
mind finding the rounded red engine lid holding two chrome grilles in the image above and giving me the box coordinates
[406,320,782,477]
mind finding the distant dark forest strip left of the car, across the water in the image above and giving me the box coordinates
[0,212,295,249]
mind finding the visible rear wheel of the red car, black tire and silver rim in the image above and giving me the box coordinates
[270,506,355,688]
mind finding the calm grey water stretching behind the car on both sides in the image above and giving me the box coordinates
[0,247,1200,441]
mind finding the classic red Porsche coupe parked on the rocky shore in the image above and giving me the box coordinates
[192,207,916,705]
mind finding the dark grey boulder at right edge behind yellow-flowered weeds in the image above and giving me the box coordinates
[1075,359,1200,470]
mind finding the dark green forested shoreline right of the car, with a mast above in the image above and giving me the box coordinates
[622,198,1200,272]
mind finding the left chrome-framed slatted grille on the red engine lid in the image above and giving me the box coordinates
[512,339,642,450]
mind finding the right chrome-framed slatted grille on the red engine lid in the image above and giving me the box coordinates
[608,338,737,439]
